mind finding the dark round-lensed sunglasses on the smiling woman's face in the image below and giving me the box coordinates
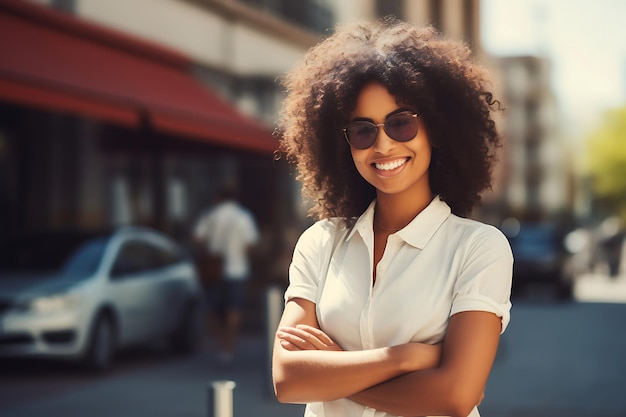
[343,112,418,149]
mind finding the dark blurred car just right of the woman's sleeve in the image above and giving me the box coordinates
[503,219,573,298]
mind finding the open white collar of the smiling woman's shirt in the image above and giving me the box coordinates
[346,196,451,249]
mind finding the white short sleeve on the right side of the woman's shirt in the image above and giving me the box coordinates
[450,227,513,332]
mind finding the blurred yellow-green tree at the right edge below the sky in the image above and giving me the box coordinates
[586,107,626,220]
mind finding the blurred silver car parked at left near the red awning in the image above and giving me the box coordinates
[0,227,202,370]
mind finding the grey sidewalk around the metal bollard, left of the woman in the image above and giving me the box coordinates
[1,336,304,417]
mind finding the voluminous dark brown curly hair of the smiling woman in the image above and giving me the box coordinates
[279,19,500,225]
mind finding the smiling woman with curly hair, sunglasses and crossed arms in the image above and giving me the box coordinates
[273,20,512,417]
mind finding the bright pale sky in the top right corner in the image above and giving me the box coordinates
[481,0,626,140]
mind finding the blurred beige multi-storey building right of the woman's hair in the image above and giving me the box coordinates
[498,56,573,221]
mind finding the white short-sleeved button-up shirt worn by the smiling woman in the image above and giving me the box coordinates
[285,197,513,417]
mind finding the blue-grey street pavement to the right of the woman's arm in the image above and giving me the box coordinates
[480,298,626,417]
